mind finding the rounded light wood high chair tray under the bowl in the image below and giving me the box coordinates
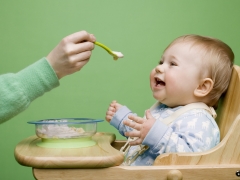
[14,132,124,168]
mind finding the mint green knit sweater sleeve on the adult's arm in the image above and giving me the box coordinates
[0,58,59,123]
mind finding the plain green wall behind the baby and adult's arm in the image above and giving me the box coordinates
[0,0,240,180]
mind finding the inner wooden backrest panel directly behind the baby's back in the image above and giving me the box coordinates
[216,65,240,140]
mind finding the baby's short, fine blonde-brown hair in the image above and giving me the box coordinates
[165,35,234,108]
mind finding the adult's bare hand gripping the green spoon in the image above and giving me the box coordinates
[47,31,96,79]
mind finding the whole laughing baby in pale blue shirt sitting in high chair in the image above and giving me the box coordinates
[106,35,234,166]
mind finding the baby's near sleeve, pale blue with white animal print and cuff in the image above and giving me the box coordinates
[143,113,219,155]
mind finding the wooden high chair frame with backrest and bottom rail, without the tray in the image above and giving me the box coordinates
[15,65,240,180]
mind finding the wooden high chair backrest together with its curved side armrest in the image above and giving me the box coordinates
[154,65,240,166]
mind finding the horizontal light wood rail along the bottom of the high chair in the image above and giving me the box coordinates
[33,165,240,180]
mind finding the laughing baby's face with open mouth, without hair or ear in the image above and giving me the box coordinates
[150,42,204,107]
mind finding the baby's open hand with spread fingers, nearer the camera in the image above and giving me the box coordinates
[123,110,156,145]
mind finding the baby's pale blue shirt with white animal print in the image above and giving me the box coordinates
[110,104,220,166]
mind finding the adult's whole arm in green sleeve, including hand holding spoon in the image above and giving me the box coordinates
[0,31,96,123]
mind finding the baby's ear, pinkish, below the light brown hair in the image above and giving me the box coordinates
[194,78,214,97]
